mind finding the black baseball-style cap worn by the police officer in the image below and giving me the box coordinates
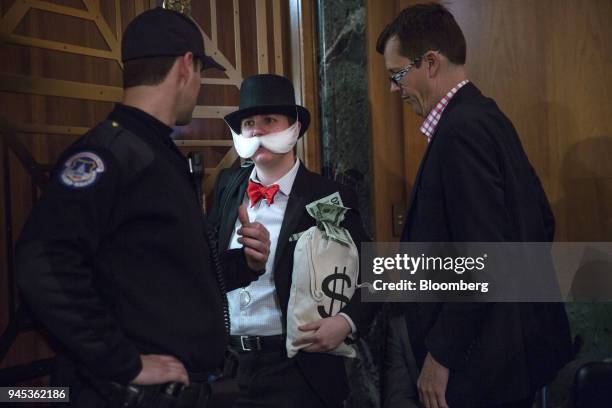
[121,7,225,71]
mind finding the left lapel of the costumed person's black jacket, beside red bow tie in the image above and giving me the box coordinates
[219,166,253,249]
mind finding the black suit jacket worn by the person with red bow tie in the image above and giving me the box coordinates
[211,164,376,407]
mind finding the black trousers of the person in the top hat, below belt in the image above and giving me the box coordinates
[234,349,335,408]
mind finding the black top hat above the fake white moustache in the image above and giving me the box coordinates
[225,74,310,137]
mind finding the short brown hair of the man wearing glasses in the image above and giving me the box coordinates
[376,3,466,65]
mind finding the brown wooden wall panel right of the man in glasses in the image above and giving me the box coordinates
[451,0,612,241]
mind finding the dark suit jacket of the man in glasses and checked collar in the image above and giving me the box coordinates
[402,83,570,407]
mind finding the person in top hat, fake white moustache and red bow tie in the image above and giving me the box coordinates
[211,75,373,408]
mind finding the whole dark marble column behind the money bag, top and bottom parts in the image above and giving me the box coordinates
[318,0,384,408]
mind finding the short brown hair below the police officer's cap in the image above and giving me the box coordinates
[123,57,198,89]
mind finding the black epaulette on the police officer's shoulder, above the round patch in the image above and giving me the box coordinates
[80,119,155,174]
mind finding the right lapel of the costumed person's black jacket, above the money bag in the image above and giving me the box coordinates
[274,163,312,271]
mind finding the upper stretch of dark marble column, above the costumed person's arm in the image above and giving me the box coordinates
[318,0,372,236]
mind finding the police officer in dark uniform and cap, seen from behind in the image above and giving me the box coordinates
[16,8,269,407]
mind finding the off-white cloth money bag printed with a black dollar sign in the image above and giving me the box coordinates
[286,226,359,357]
